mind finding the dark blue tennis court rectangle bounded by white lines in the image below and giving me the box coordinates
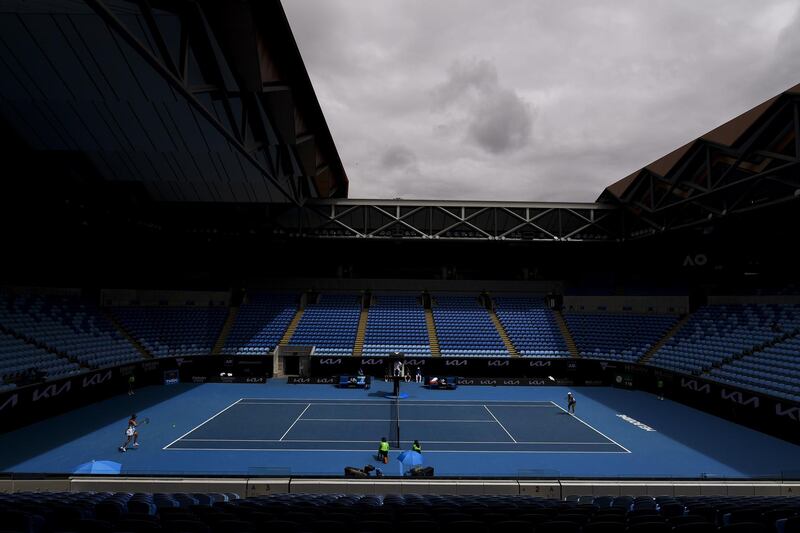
[164,398,630,453]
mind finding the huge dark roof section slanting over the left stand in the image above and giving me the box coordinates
[0,0,348,204]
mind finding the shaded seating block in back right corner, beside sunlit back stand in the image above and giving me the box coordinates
[564,312,678,362]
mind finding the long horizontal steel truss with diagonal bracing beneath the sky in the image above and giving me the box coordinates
[278,200,623,242]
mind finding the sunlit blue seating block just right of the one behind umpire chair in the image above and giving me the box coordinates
[433,295,509,357]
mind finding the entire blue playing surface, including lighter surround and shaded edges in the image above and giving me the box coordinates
[0,380,800,479]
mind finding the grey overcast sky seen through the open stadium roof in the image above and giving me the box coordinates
[283,0,800,202]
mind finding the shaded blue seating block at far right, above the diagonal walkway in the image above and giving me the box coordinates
[649,304,800,373]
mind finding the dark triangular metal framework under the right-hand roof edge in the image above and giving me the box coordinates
[601,93,800,238]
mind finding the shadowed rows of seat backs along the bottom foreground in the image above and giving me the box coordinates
[0,492,800,533]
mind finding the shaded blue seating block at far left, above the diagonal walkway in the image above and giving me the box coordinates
[0,292,141,368]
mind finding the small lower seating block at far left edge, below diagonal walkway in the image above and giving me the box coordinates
[0,331,81,382]
